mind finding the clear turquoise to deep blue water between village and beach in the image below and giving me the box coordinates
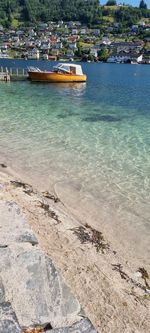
[0,61,150,256]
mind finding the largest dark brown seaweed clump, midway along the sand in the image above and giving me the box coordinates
[72,224,109,253]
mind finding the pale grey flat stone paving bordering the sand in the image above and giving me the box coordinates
[0,201,96,333]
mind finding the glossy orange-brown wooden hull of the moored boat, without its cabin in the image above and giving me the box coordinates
[28,71,87,82]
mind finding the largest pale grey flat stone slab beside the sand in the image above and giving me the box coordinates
[0,244,81,328]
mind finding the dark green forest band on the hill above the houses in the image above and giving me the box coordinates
[0,0,150,27]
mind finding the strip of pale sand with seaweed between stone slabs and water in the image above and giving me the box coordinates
[0,165,150,333]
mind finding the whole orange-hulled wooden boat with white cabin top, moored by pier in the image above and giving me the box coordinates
[28,63,87,82]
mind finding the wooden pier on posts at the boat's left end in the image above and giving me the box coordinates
[0,66,28,82]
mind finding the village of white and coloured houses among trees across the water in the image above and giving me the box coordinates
[0,2,150,64]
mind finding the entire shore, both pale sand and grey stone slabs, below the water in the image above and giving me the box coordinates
[0,172,150,333]
